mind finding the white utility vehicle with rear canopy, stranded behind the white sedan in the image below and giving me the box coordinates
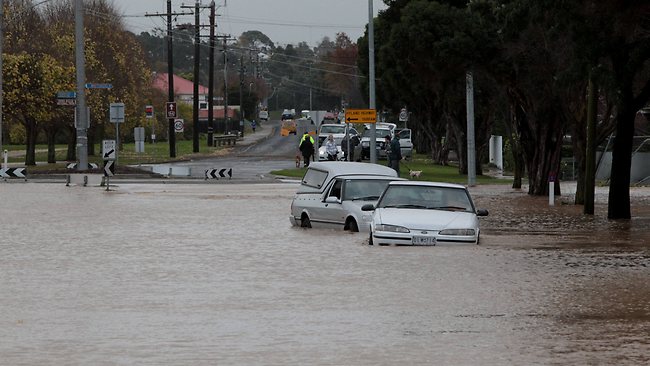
[289,161,403,231]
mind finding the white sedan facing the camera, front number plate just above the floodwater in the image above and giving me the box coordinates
[362,181,488,245]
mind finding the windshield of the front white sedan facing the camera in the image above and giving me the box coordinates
[377,185,474,212]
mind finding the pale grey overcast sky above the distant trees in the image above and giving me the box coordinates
[113,0,386,46]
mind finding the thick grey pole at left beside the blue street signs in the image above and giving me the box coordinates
[75,0,88,171]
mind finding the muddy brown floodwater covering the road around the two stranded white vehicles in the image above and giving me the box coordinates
[0,182,650,365]
